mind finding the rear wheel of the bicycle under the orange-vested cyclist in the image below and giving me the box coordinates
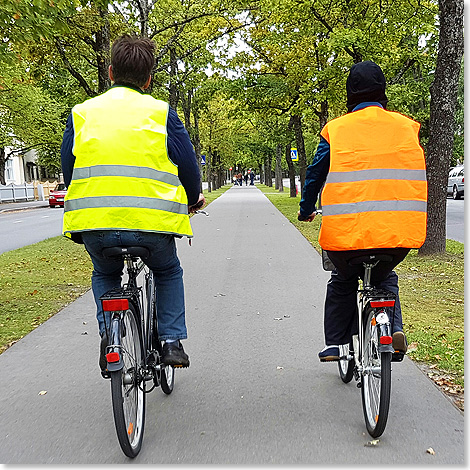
[361,309,392,437]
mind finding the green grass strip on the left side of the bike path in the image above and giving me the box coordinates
[0,185,231,353]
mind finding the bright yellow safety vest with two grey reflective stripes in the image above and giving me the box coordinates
[63,87,192,237]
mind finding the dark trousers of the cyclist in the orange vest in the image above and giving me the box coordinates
[324,248,410,346]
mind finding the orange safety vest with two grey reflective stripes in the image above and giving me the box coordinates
[318,106,427,251]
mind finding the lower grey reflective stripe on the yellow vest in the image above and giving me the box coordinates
[64,196,188,215]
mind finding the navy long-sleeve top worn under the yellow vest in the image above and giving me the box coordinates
[60,85,201,206]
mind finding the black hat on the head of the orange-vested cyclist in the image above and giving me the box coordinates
[346,60,388,113]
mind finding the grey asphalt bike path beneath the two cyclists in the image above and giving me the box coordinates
[0,186,464,465]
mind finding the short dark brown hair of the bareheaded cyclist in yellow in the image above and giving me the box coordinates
[111,35,155,88]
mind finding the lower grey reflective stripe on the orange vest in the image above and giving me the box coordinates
[322,200,427,216]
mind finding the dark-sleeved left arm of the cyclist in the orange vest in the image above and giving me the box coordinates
[299,137,330,220]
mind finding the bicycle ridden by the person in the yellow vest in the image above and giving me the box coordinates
[100,207,209,458]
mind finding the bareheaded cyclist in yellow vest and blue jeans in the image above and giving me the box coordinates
[61,35,205,377]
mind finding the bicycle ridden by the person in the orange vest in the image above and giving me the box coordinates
[298,209,404,438]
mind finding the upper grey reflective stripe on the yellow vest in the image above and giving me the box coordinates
[72,165,181,186]
